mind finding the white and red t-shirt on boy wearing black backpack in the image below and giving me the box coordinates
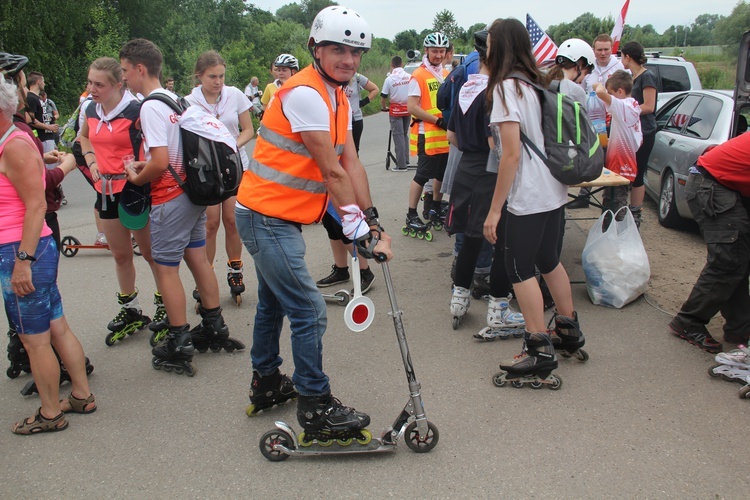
[141,88,185,205]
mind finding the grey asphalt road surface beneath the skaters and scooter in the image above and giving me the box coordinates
[0,111,750,498]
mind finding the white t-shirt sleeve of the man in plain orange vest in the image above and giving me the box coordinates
[281,84,352,133]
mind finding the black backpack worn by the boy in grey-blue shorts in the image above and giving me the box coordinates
[138,92,242,206]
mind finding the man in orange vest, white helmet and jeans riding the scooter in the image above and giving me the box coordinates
[235,5,393,437]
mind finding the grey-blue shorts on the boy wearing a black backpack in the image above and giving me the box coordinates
[150,193,206,267]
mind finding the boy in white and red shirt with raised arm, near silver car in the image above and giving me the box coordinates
[592,70,643,220]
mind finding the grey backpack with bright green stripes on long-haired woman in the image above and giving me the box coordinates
[510,72,604,186]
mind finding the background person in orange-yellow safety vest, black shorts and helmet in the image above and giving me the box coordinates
[405,32,450,233]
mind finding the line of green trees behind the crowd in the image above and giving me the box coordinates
[0,0,750,115]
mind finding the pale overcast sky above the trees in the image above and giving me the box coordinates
[250,0,737,43]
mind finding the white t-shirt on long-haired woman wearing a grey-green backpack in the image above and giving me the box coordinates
[490,78,568,215]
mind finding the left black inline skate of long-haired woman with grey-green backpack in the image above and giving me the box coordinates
[492,332,562,390]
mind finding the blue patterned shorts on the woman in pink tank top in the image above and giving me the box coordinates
[0,236,63,335]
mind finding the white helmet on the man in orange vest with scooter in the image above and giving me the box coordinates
[307,5,372,51]
